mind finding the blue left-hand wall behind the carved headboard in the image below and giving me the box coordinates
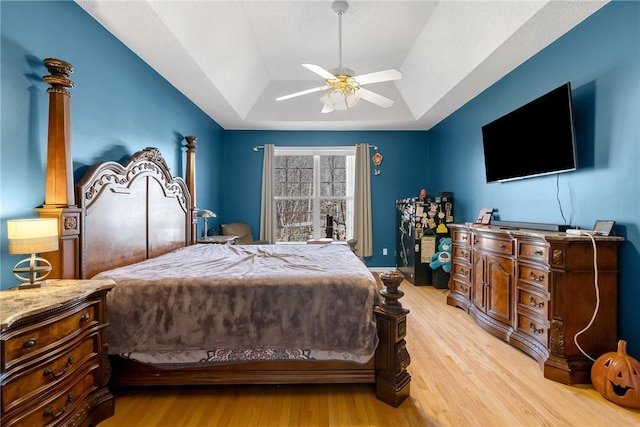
[0,1,223,289]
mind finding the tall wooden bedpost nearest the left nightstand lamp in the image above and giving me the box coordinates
[36,58,81,279]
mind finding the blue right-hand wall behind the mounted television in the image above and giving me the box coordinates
[428,1,640,358]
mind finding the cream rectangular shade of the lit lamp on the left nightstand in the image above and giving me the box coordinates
[7,218,58,254]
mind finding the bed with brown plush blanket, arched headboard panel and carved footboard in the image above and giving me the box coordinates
[70,148,410,406]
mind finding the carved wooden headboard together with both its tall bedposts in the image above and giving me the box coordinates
[36,58,196,279]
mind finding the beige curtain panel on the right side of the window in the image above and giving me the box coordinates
[353,144,373,257]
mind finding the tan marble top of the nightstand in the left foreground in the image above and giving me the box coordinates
[0,279,115,330]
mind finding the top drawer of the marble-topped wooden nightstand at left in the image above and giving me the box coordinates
[2,301,100,372]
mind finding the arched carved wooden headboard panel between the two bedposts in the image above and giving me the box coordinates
[76,148,192,279]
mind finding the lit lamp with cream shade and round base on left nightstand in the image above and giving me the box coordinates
[7,218,58,289]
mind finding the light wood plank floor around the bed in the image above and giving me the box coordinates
[100,281,640,427]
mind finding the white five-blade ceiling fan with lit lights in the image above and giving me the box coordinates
[276,1,402,113]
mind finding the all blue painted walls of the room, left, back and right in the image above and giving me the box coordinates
[0,1,640,358]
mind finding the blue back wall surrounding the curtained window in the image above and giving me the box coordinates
[224,131,430,268]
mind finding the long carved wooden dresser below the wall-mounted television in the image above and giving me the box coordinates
[447,224,624,384]
